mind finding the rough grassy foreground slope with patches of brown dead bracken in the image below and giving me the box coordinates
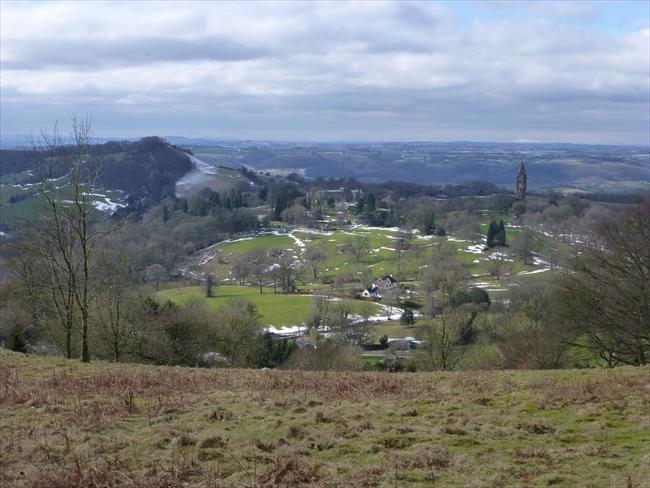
[0,350,650,487]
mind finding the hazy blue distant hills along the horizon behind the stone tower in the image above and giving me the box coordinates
[184,142,650,191]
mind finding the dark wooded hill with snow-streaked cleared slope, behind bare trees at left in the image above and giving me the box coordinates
[0,137,251,228]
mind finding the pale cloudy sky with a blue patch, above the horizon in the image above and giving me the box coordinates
[0,0,650,144]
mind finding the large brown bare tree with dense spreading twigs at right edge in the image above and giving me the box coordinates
[560,198,650,366]
